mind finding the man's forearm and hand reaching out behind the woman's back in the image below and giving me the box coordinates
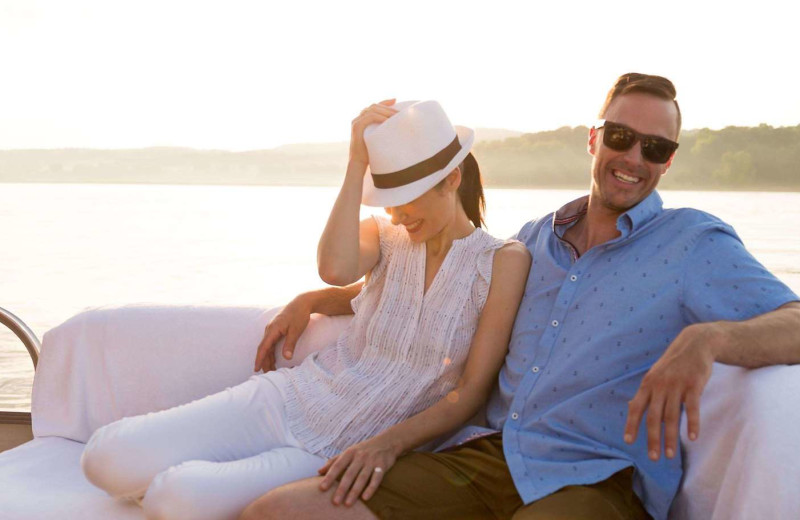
[253,282,364,372]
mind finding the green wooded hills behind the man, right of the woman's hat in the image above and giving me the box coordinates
[475,125,800,190]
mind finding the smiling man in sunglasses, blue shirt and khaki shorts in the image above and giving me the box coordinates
[242,74,800,519]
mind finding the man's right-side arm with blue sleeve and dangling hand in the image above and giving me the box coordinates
[624,226,800,460]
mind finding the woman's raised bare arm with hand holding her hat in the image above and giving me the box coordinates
[317,100,397,285]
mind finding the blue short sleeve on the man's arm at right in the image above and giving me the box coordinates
[681,226,798,323]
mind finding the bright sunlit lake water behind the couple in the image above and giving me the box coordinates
[0,184,800,410]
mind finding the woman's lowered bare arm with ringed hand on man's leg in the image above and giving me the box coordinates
[320,242,531,505]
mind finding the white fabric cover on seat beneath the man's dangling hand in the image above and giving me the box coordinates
[670,364,800,520]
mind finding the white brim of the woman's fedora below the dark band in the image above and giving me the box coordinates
[361,126,475,208]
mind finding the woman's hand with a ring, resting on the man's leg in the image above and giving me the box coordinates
[319,435,400,506]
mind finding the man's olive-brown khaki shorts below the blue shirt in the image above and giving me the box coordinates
[365,433,650,520]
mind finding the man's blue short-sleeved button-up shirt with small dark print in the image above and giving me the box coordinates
[478,192,798,519]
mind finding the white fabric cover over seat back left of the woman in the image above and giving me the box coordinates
[31,306,349,442]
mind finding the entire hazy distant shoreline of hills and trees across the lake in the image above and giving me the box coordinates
[0,125,800,191]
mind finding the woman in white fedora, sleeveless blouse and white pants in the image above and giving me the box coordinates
[81,101,530,519]
